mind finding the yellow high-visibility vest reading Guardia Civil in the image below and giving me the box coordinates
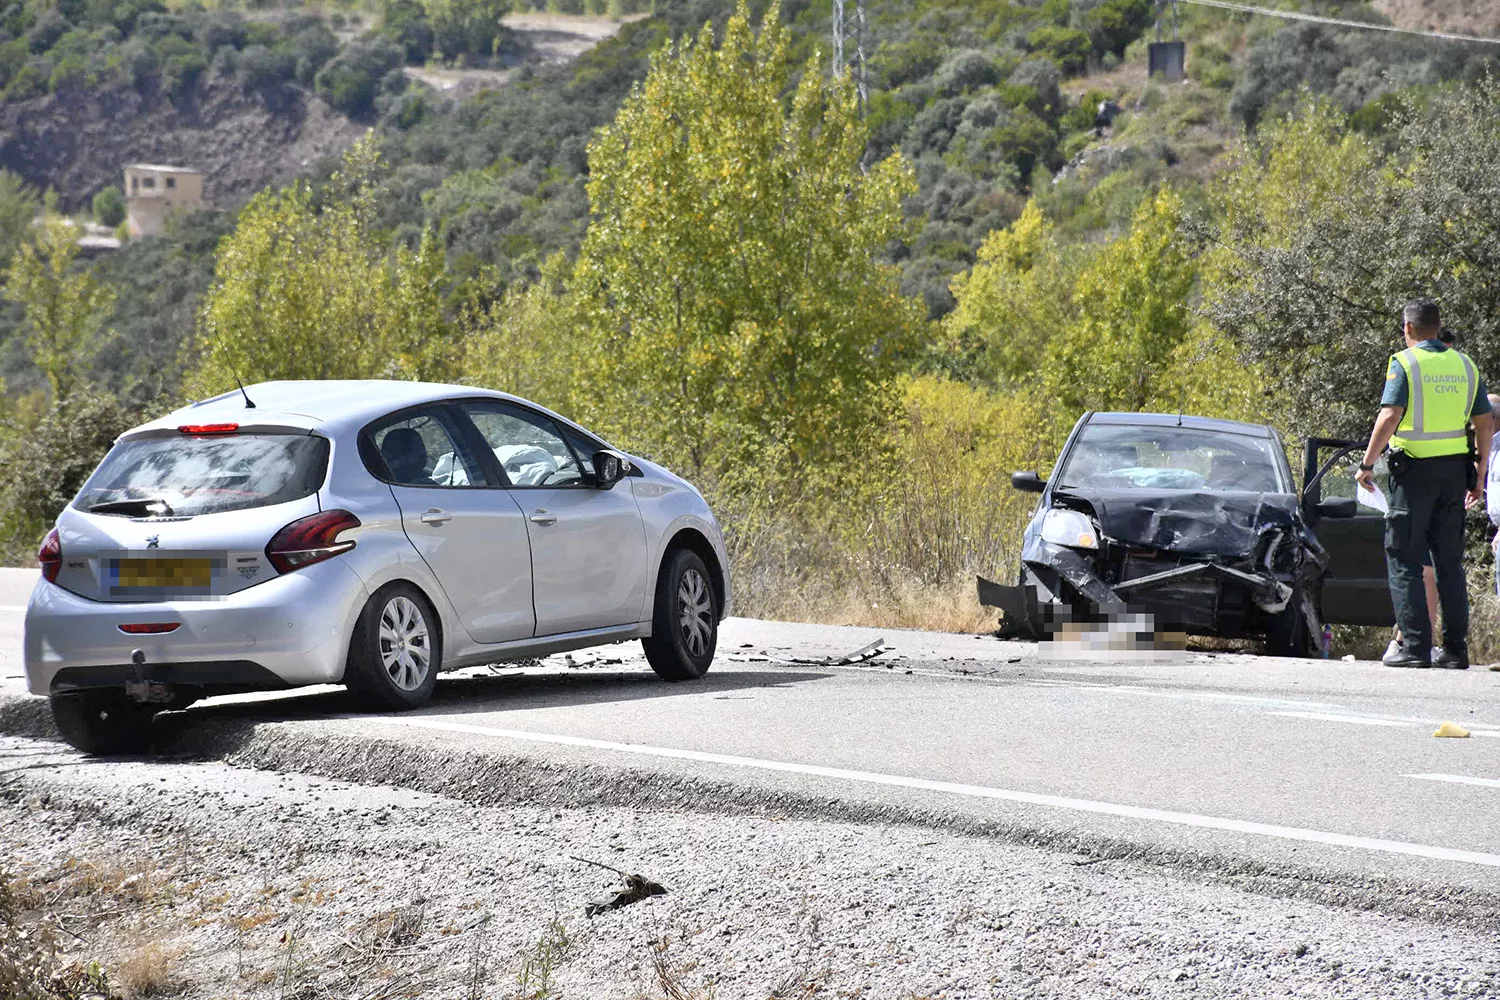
[1391,348,1479,459]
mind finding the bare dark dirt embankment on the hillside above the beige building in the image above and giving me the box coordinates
[0,84,365,210]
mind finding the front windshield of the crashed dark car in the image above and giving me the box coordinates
[1056,424,1287,493]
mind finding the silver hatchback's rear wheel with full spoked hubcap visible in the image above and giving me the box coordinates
[344,583,443,712]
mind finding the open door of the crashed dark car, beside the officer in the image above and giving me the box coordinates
[1302,438,1395,625]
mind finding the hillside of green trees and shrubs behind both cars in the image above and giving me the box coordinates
[0,0,1500,641]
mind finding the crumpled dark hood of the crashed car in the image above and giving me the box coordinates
[1053,489,1316,558]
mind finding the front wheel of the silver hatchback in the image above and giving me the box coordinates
[641,549,719,681]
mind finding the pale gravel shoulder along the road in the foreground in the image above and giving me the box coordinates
[0,738,1500,1000]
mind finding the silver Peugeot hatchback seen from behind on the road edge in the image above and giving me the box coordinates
[24,381,729,753]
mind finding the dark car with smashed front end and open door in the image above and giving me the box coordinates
[980,412,1394,657]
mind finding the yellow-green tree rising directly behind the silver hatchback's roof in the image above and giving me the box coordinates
[185,139,452,394]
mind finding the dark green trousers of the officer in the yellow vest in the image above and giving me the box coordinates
[1386,454,1472,660]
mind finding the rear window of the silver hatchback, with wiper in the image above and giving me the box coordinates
[74,435,329,517]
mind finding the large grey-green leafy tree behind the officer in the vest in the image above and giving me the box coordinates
[1199,88,1500,436]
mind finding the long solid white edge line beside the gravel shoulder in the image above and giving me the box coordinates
[381,718,1500,868]
